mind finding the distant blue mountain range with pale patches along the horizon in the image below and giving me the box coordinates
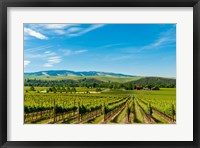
[24,70,137,77]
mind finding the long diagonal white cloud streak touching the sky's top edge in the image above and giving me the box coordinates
[68,24,105,37]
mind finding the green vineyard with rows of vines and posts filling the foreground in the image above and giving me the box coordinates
[24,88,176,124]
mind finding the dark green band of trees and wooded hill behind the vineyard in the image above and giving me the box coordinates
[24,78,176,89]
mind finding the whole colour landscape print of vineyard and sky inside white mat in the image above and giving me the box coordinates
[22,23,177,126]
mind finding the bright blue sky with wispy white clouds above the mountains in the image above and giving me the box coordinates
[24,24,176,77]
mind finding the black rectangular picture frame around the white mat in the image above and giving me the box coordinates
[0,0,200,148]
